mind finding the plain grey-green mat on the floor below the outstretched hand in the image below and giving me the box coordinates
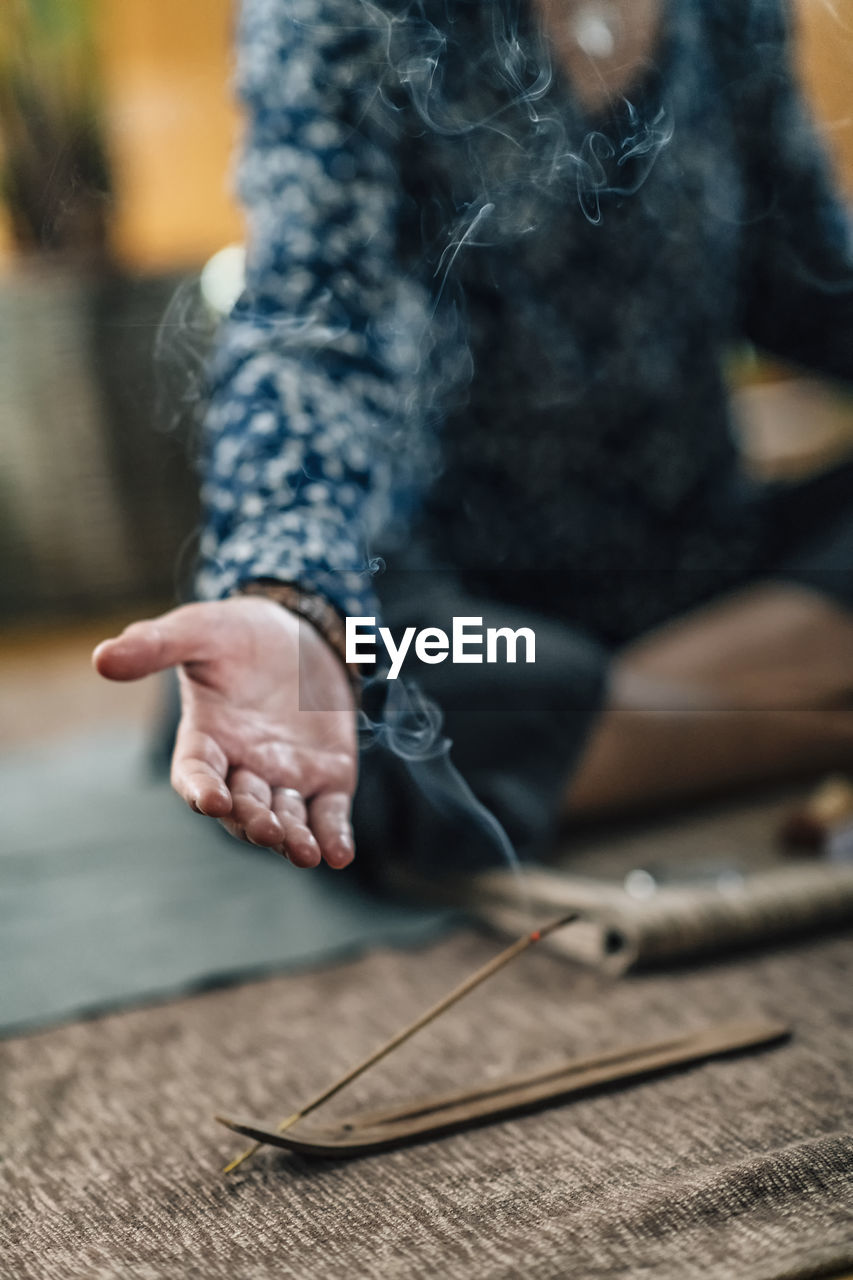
[0,730,452,1033]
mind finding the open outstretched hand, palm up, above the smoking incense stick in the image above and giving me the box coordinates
[92,596,357,868]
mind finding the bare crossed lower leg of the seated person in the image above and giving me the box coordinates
[566,582,853,817]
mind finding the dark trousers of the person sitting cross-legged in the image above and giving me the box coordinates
[355,463,853,881]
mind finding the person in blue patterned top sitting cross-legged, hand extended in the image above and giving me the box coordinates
[96,0,853,867]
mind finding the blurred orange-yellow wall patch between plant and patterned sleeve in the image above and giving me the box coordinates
[95,0,242,271]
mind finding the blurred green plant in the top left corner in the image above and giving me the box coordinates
[0,0,110,257]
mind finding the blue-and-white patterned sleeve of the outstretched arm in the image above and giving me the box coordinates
[197,0,425,613]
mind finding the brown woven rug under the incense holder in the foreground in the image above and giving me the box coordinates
[0,916,853,1280]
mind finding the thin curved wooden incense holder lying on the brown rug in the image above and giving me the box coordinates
[216,1019,789,1158]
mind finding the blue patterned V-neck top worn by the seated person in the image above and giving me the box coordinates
[199,0,853,640]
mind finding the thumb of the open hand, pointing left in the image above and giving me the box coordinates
[92,604,209,680]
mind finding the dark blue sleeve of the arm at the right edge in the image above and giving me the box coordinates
[740,0,853,381]
